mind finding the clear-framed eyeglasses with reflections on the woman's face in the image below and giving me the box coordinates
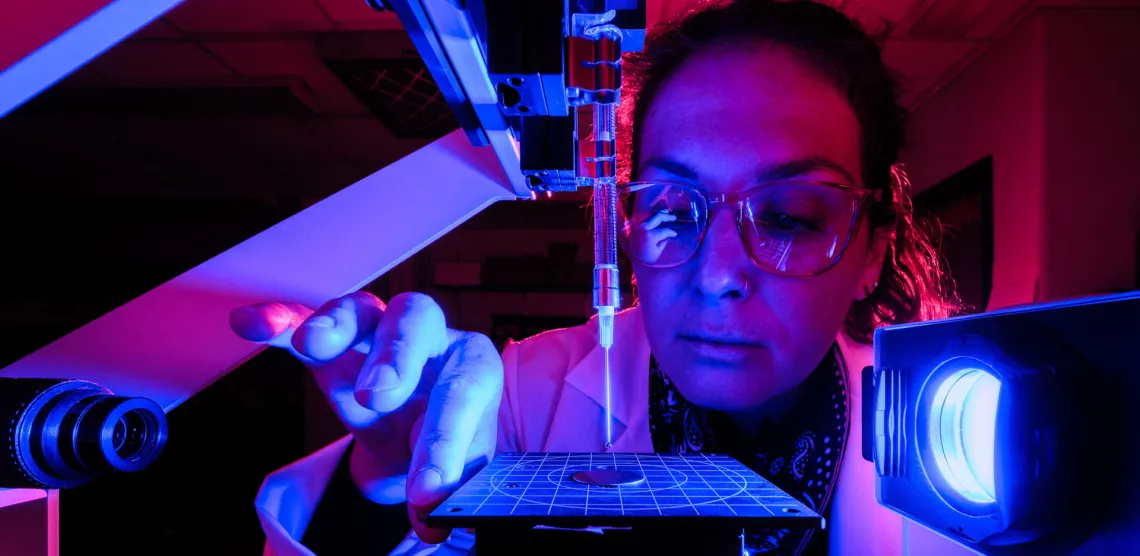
[618,180,881,277]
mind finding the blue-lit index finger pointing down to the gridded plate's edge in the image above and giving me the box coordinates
[408,334,503,534]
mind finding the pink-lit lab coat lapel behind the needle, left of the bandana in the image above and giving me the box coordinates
[559,306,650,451]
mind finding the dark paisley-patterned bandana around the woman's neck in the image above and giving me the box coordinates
[649,344,849,556]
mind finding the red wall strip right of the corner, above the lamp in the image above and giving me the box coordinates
[1041,9,1140,299]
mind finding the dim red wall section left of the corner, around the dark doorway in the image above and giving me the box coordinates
[903,13,1045,309]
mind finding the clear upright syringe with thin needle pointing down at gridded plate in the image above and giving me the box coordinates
[594,104,621,448]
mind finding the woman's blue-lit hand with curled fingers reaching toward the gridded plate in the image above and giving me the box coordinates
[230,292,503,542]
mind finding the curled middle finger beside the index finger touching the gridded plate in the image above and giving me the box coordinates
[355,294,449,414]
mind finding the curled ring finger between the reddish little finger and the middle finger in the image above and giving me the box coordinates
[292,292,384,362]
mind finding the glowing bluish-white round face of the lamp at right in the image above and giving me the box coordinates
[929,368,1001,504]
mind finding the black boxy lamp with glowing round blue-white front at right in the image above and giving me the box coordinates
[863,292,1140,555]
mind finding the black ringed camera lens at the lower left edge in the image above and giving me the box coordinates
[0,378,166,489]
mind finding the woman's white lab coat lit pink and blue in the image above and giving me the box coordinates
[255,308,902,556]
